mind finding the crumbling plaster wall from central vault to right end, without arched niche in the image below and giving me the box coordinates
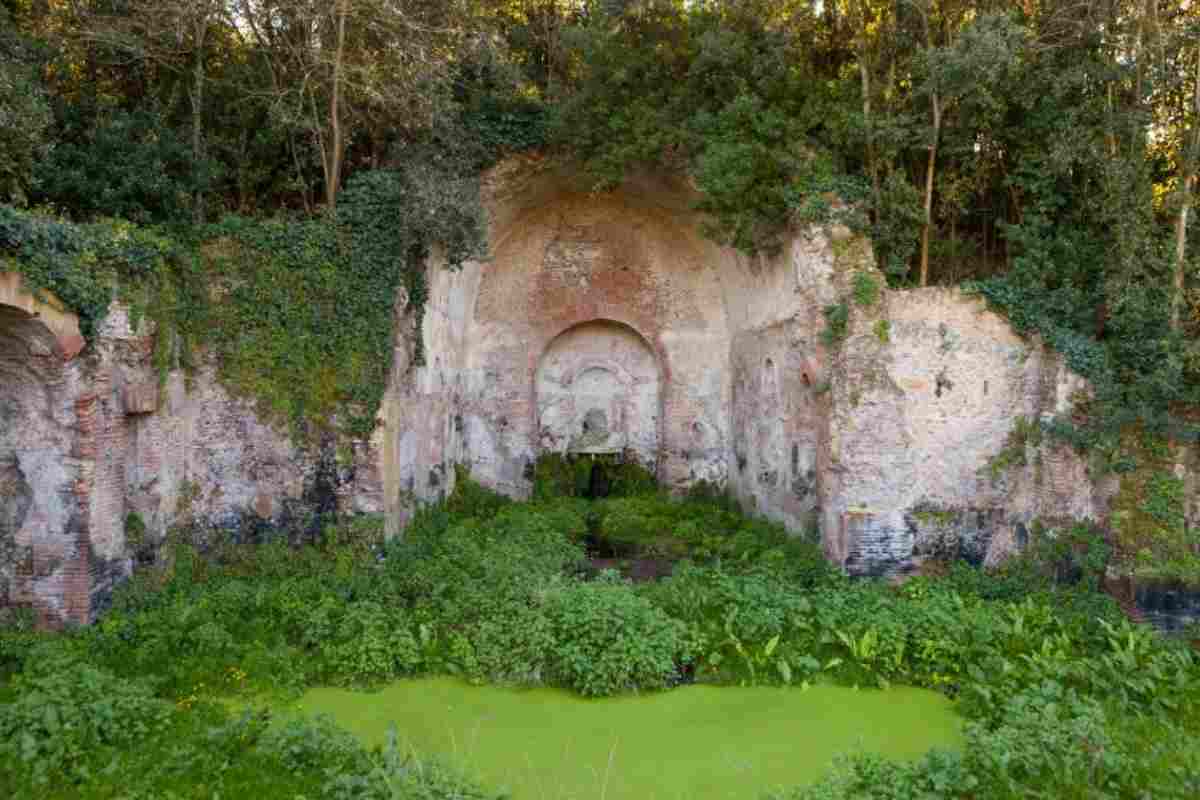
[380,162,1152,575]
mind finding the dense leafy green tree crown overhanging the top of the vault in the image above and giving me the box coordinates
[554,4,834,252]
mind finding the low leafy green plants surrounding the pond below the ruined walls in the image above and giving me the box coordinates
[0,475,1200,799]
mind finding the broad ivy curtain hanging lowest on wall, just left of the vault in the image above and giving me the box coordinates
[205,172,444,437]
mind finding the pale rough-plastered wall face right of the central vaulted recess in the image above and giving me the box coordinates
[823,280,1108,575]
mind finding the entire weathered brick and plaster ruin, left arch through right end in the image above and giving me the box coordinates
[0,160,1200,621]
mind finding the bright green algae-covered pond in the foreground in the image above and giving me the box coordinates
[292,679,961,800]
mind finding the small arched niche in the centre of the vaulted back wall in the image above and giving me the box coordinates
[534,319,662,465]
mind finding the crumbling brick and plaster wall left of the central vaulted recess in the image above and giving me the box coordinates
[0,272,383,625]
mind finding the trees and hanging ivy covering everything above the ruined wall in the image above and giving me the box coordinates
[0,0,1200,525]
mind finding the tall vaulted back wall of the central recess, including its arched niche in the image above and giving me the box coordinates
[384,169,730,513]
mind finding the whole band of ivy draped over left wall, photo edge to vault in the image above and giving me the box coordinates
[0,149,492,441]
